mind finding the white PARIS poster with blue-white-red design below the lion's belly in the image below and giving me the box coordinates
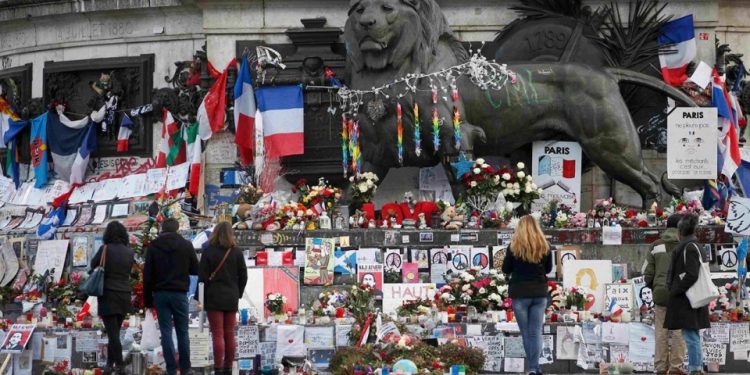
[531,141,583,211]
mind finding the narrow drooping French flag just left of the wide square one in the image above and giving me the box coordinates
[234,57,256,165]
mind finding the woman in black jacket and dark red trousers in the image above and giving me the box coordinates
[196,221,247,375]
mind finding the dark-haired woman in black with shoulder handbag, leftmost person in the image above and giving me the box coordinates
[91,221,135,375]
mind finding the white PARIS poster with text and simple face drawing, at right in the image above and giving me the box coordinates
[667,108,718,180]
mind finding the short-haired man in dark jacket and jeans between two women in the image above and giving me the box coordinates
[143,219,198,375]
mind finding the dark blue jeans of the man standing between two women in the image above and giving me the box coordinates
[154,291,190,375]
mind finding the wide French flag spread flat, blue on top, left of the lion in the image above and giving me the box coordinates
[256,86,305,160]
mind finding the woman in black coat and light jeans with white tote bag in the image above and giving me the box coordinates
[664,214,711,375]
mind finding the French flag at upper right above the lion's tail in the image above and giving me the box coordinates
[657,14,696,86]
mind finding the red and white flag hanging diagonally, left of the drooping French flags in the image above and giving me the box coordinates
[196,59,236,141]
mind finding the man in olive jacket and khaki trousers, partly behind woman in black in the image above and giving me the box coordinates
[643,214,685,375]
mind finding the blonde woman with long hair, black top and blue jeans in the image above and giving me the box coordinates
[503,215,552,375]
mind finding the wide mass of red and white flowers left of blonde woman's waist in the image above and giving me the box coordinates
[435,268,508,313]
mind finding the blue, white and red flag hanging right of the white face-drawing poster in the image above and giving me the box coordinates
[711,71,742,179]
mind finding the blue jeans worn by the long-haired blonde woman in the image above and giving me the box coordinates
[513,297,547,374]
